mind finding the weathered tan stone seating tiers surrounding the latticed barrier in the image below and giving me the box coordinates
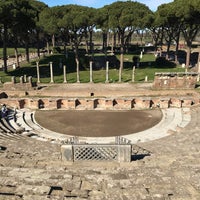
[0,107,200,200]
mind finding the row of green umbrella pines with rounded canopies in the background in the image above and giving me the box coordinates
[0,0,200,77]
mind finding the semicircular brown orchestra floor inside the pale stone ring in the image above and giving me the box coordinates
[35,109,162,137]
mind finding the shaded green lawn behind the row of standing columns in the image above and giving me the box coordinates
[0,52,184,83]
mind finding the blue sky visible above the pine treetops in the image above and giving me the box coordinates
[40,0,173,11]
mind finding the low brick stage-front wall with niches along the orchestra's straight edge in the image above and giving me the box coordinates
[0,96,197,110]
